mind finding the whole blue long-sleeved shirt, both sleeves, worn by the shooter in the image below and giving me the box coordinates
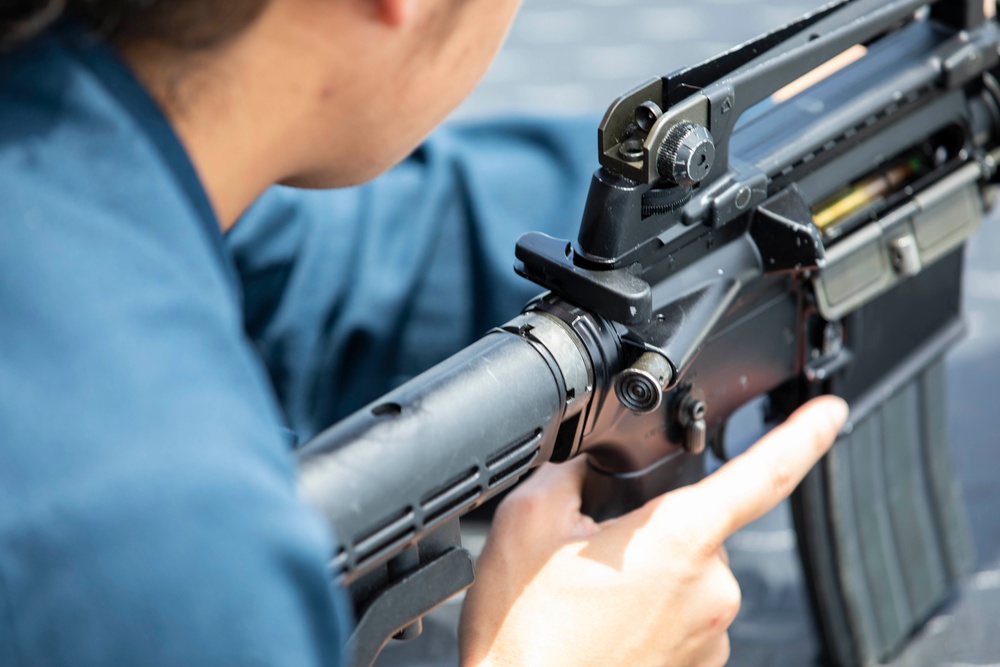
[0,23,593,666]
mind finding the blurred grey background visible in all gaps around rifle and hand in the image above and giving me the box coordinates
[387,0,1000,667]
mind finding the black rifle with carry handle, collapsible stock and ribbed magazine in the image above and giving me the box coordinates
[298,0,1000,665]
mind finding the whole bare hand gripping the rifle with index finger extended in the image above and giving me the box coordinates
[460,397,847,667]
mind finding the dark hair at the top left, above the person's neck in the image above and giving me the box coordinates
[0,0,268,50]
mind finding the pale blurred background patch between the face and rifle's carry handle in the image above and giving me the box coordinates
[458,0,823,116]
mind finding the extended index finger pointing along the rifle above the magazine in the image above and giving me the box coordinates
[691,396,848,541]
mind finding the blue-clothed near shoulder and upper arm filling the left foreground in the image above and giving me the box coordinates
[0,32,344,664]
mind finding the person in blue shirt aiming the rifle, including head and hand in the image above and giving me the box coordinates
[0,0,846,666]
